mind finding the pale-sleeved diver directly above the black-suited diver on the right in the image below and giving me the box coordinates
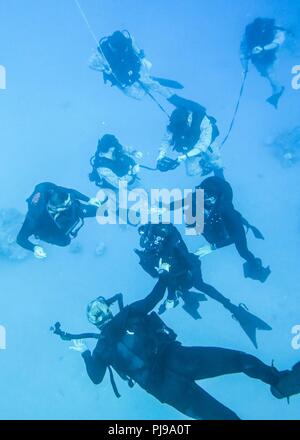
[157,95,223,176]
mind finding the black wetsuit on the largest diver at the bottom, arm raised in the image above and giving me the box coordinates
[82,279,278,420]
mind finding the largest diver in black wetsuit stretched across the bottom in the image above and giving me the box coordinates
[52,274,300,420]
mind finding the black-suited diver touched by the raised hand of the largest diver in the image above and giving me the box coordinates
[135,223,271,348]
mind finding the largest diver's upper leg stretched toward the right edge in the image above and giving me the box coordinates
[167,346,279,385]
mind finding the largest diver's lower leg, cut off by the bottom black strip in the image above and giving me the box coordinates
[158,370,239,420]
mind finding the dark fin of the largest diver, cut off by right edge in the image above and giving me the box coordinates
[271,362,300,399]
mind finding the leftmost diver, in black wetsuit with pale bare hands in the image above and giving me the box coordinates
[17,182,102,259]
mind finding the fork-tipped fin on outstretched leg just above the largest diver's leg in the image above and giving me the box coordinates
[226,304,272,348]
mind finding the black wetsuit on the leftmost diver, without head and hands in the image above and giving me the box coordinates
[17,182,97,251]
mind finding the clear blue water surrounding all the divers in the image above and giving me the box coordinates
[0,0,300,419]
